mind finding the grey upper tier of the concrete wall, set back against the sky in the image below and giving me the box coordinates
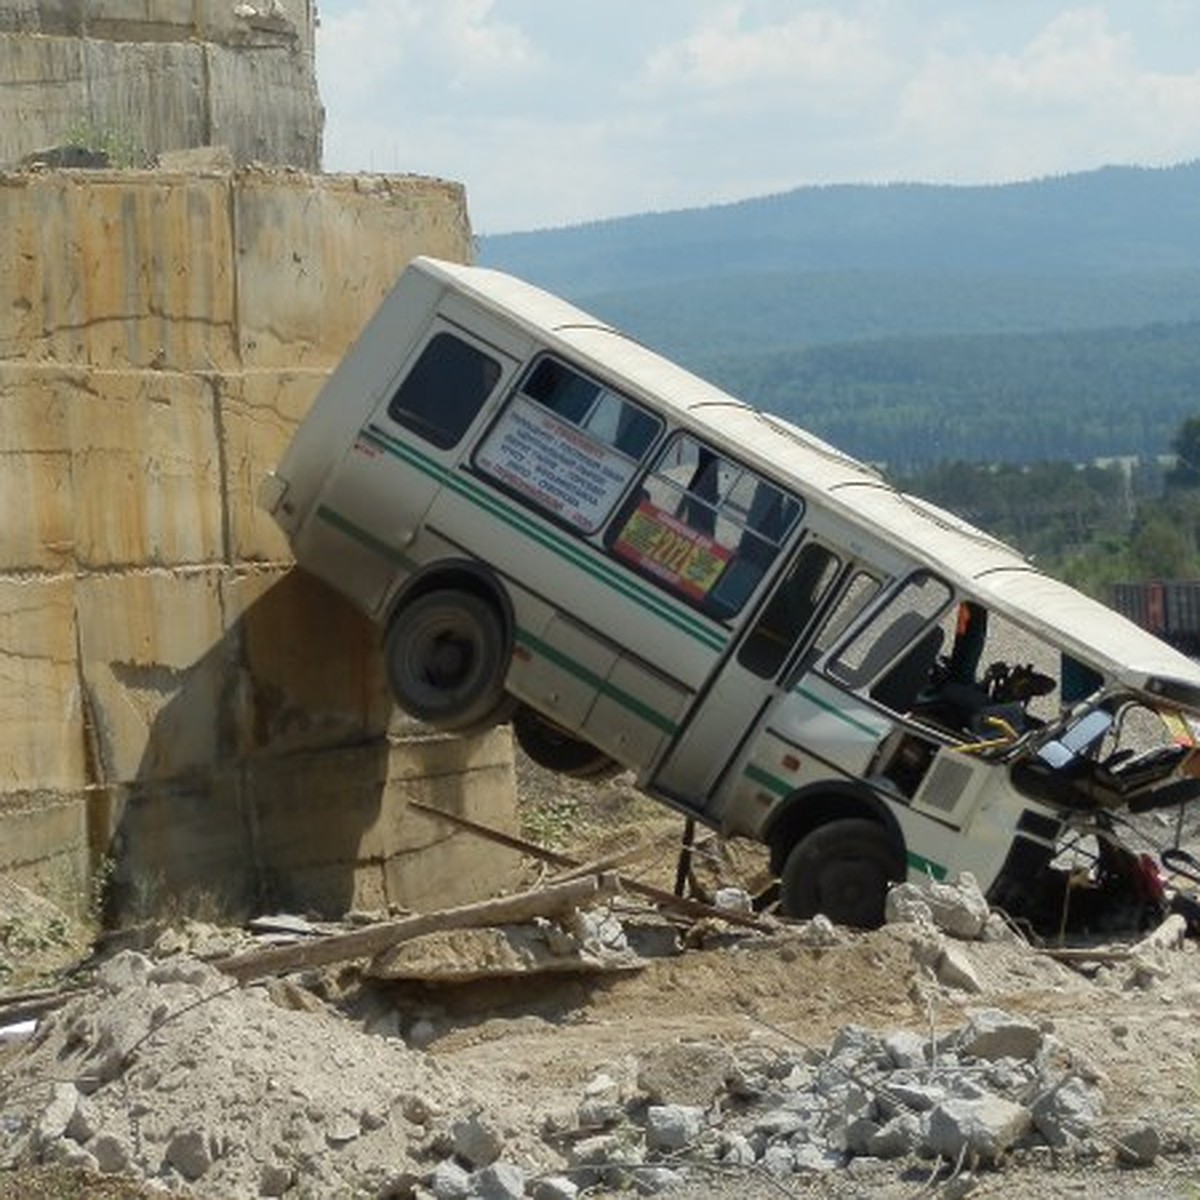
[0,0,324,170]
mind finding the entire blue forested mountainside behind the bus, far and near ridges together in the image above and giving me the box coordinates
[479,161,1200,470]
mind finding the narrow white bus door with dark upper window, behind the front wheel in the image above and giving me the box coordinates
[654,535,844,810]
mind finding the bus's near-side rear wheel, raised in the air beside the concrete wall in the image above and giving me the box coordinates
[384,589,509,733]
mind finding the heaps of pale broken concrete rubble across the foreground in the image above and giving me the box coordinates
[0,888,1180,1200]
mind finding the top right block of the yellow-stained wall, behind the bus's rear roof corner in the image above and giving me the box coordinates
[234,172,470,370]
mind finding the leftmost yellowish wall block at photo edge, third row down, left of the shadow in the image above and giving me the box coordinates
[0,576,86,792]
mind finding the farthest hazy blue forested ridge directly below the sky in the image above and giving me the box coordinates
[480,161,1200,298]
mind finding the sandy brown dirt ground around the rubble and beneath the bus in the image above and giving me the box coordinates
[0,762,1200,1200]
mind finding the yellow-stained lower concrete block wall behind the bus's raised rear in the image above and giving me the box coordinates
[0,170,525,914]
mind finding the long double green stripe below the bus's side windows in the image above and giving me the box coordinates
[360,426,726,653]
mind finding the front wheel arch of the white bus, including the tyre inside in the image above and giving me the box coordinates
[769,785,906,929]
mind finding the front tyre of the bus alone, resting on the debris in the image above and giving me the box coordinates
[779,817,905,929]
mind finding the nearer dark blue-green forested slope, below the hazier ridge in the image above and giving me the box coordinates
[695,322,1200,472]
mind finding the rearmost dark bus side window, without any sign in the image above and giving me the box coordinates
[388,334,500,450]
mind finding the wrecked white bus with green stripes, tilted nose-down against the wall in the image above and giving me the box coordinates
[262,258,1200,929]
